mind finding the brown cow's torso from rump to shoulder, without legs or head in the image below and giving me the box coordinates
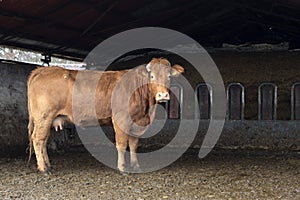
[28,67,128,126]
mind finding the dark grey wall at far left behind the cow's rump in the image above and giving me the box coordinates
[0,62,34,153]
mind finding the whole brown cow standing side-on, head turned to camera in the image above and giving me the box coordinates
[27,58,184,173]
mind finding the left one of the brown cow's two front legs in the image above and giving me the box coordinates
[113,121,128,173]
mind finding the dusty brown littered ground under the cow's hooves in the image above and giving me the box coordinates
[0,153,300,199]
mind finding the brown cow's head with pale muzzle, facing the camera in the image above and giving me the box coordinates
[145,58,184,102]
